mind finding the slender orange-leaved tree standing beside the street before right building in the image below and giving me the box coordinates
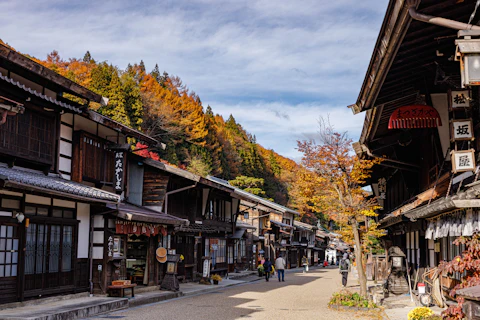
[298,120,383,297]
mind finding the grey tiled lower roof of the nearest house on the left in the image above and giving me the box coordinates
[0,166,120,202]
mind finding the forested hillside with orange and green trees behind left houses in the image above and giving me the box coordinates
[4,45,297,204]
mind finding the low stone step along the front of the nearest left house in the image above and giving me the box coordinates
[0,297,128,320]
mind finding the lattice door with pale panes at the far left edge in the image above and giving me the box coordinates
[0,224,20,303]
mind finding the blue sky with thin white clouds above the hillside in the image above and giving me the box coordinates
[0,0,388,159]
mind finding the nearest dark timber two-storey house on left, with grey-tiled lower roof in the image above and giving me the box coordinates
[0,45,124,303]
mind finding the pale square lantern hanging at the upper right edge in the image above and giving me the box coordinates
[455,30,480,88]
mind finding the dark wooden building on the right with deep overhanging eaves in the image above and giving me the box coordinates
[350,0,480,290]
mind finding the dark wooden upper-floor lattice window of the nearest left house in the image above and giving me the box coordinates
[0,109,56,165]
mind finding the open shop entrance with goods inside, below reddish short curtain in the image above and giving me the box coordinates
[126,234,149,285]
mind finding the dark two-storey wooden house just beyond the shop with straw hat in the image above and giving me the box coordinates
[127,159,248,281]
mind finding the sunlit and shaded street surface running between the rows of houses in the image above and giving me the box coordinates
[99,269,371,320]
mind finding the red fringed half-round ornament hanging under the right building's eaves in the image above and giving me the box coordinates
[388,105,442,129]
